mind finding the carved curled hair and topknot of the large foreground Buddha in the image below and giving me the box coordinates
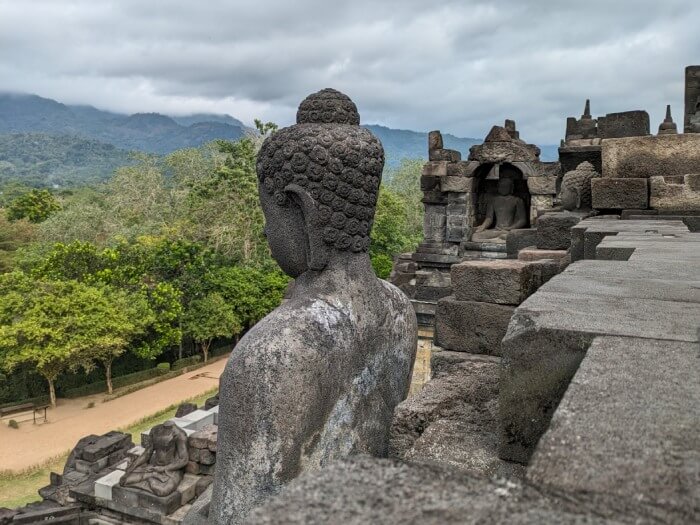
[257,89,384,252]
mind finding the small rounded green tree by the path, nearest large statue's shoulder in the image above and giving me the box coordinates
[182,293,242,363]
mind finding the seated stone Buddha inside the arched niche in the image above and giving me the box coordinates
[472,177,527,242]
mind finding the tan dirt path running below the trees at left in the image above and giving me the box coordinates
[0,359,226,471]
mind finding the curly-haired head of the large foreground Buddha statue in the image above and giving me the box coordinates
[257,89,384,277]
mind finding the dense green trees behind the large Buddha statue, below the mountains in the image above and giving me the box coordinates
[0,128,422,402]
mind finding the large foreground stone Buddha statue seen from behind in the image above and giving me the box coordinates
[208,89,417,525]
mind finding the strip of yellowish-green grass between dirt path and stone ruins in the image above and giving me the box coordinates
[0,388,218,508]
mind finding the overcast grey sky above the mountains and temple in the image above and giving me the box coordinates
[0,0,700,144]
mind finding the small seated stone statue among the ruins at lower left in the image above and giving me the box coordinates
[119,421,189,496]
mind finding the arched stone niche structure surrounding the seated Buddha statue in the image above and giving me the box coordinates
[389,120,561,320]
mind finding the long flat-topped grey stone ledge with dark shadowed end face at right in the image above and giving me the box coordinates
[500,233,700,463]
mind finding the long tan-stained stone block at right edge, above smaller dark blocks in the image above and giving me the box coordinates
[602,133,700,178]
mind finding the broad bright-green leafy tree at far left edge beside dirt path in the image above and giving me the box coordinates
[0,272,144,406]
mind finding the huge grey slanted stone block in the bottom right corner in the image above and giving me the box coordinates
[527,337,700,523]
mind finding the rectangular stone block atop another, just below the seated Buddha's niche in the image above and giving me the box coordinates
[451,259,556,305]
